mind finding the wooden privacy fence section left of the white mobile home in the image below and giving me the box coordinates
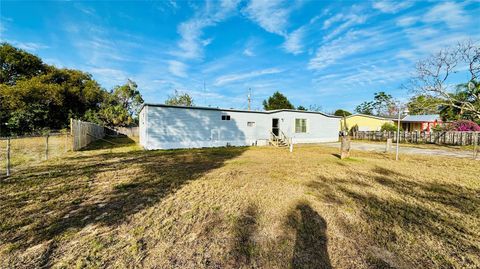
[70,119,105,151]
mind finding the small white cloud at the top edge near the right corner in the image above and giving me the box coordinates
[423,2,469,28]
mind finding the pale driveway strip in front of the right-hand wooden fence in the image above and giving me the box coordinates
[323,141,480,160]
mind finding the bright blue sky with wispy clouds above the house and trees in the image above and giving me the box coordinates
[0,0,480,112]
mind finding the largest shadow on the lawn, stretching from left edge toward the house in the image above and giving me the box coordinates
[0,139,247,250]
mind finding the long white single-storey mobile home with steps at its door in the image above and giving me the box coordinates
[139,104,341,149]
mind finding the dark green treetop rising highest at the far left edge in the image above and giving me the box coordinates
[0,43,48,85]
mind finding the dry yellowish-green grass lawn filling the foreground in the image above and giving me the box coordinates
[0,139,480,268]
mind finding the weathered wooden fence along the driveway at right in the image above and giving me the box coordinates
[352,131,480,146]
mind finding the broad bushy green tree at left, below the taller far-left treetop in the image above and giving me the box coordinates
[0,69,106,135]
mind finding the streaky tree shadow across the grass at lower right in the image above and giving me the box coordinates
[306,166,480,267]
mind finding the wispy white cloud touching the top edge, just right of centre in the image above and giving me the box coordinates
[243,0,291,36]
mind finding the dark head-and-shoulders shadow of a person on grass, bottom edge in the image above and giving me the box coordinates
[287,202,332,269]
